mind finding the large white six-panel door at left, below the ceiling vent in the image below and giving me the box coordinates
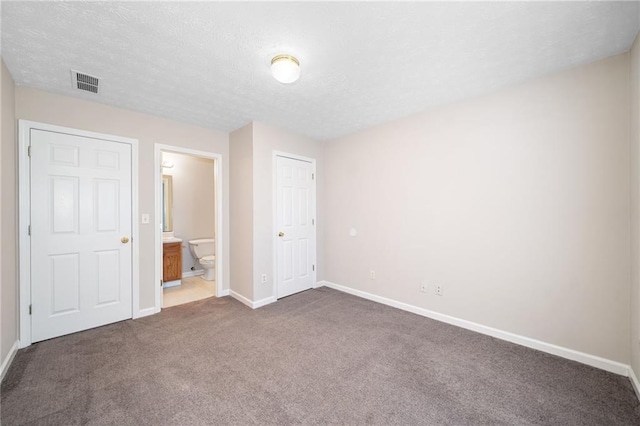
[30,129,132,342]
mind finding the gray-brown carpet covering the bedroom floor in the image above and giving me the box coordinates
[0,288,640,426]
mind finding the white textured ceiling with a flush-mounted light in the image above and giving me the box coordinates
[1,1,640,139]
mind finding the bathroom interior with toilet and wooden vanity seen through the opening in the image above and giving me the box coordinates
[162,152,217,308]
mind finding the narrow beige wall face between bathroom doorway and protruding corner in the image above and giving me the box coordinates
[229,124,253,300]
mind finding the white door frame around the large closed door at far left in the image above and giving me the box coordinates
[18,120,140,348]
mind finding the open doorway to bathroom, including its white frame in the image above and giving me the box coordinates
[154,144,222,310]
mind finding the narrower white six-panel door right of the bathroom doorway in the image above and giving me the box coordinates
[276,156,316,298]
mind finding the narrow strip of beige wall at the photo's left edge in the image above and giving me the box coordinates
[0,61,18,364]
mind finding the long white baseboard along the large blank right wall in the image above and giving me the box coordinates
[324,281,630,376]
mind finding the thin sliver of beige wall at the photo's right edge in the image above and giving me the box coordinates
[629,31,640,377]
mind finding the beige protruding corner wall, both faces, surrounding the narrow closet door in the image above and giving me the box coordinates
[229,122,323,302]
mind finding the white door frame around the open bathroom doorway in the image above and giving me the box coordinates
[153,143,224,312]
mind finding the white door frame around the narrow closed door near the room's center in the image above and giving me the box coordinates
[271,151,318,300]
